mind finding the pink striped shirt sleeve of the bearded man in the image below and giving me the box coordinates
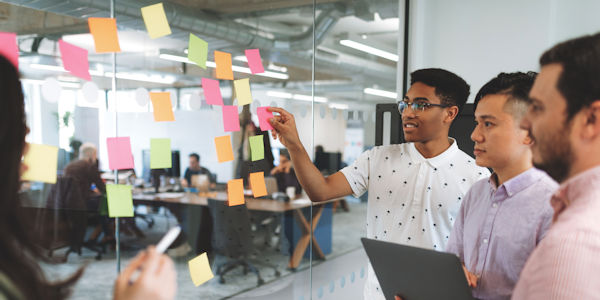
[513,230,600,299]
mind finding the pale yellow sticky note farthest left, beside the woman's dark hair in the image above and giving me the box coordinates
[21,144,58,184]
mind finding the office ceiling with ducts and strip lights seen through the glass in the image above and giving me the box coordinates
[0,0,398,107]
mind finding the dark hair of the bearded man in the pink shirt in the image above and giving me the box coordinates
[540,33,600,121]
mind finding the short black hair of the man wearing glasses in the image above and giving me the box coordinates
[410,68,471,112]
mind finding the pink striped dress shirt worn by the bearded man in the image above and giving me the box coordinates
[512,166,600,300]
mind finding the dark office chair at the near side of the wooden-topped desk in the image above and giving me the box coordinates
[208,199,280,285]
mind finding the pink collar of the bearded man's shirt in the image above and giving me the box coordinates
[550,166,600,221]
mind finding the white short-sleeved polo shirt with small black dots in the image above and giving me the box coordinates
[341,139,490,300]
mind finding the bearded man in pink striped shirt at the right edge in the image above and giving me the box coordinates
[513,33,600,300]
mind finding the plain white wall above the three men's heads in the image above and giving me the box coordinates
[397,0,600,102]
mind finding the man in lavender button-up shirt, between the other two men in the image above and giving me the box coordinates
[446,72,558,300]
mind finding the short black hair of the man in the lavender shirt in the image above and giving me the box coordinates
[473,71,537,115]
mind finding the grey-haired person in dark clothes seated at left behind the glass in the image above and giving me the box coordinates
[63,143,106,210]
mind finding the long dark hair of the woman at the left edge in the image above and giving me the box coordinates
[0,55,83,299]
